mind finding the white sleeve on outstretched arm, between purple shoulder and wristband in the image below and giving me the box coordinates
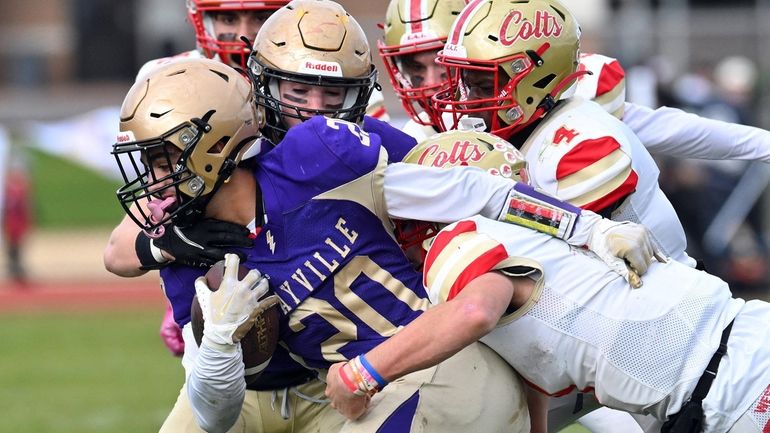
[384,163,516,223]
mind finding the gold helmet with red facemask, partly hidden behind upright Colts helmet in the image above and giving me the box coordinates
[377,0,465,125]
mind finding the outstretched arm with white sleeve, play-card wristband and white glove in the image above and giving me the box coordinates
[384,163,662,287]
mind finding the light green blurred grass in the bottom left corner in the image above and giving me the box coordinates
[0,308,184,433]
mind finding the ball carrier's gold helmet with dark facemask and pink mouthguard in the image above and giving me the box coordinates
[112,59,261,233]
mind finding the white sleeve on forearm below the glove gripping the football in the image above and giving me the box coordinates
[187,343,246,433]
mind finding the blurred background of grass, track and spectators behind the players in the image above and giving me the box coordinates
[0,0,770,432]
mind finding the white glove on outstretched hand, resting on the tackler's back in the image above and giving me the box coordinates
[586,218,666,288]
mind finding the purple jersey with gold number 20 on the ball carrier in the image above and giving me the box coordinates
[246,116,428,368]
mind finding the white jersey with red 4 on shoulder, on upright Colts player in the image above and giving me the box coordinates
[521,97,695,266]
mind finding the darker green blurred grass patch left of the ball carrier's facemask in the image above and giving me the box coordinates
[28,148,124,229]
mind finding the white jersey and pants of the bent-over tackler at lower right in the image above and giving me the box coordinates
[424,217,770,432]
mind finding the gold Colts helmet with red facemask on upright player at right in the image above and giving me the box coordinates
[430,0,584,138]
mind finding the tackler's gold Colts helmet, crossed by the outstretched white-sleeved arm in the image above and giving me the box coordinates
[394,130,529,269]
